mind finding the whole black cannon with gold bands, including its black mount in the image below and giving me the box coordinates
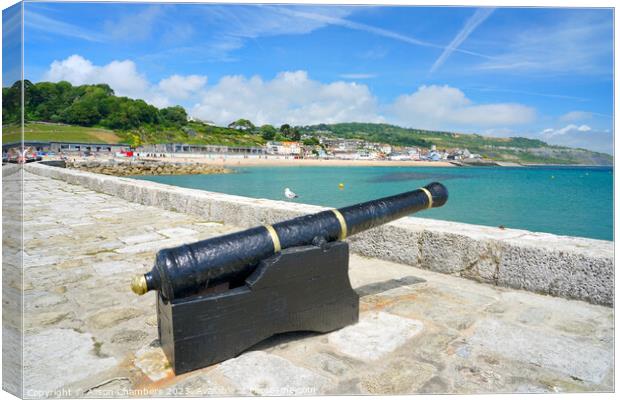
[131,182,448,373]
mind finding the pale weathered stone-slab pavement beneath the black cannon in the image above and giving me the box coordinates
[17,173,614,397]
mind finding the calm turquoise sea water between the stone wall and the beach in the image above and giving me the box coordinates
[137,167,613,240]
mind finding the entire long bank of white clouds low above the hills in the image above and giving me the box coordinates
[44,55,536,130]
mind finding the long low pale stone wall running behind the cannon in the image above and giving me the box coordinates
[26,164,614,306]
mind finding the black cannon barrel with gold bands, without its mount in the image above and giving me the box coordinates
[131,182,448,300]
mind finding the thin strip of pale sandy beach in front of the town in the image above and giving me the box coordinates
[139,156,455,167]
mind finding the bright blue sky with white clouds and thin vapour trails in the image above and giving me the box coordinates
[4,3,613,153]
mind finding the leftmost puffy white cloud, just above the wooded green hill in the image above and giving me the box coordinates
[43,54,207,107]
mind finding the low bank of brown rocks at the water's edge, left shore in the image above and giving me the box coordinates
[66,160,232,176]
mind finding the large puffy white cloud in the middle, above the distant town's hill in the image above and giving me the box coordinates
[191,71,382,125]
